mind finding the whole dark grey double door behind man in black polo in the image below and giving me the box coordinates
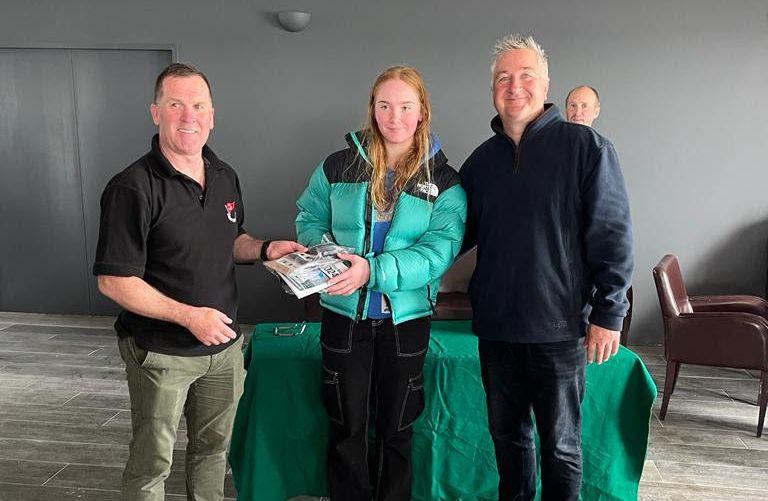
[0,49,171,314]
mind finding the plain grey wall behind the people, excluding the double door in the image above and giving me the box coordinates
[0,0,768,343]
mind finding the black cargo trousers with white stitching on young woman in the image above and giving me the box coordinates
[320,309,430,501]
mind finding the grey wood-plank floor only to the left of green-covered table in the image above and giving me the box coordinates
[0,313,236,501]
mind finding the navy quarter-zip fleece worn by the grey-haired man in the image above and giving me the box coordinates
[459,104,633,343]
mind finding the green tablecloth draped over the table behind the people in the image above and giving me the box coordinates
[229,321,656,501]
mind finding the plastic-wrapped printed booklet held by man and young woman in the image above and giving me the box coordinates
[264,234,354,299]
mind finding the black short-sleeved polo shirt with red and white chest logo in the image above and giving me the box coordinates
[93,135,245,356]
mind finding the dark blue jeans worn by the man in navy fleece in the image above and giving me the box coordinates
[479,339,586,501]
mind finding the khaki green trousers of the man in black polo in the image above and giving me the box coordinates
[119,337,244,501]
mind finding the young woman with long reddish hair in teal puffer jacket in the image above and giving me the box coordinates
[296,66,467,501]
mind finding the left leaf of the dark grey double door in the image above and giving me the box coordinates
[0,49,88,313]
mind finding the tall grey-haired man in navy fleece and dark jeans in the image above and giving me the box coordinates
[460,35,633,500]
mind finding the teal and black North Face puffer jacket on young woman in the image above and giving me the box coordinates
[296,132,467,324]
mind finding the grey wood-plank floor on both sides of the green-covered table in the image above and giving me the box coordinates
[0,313,768,501]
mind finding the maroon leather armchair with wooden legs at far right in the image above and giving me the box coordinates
[653,254,768,437]
